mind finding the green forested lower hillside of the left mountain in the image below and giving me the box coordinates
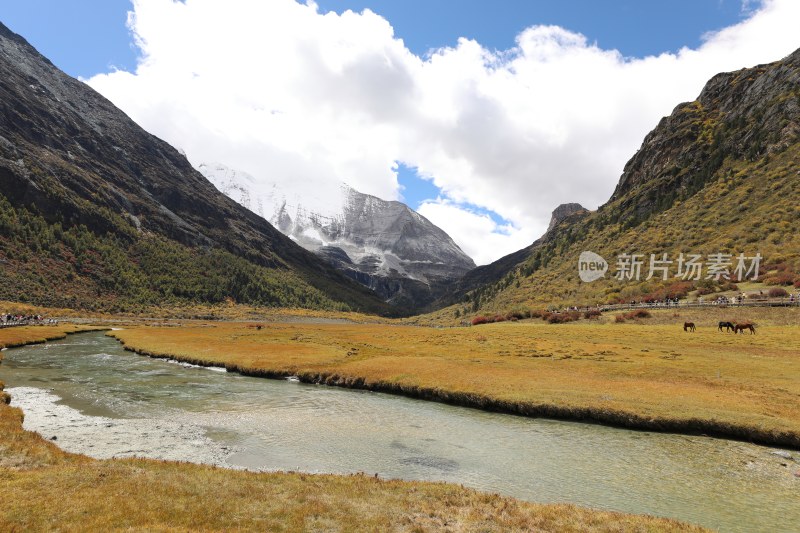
[0,191,349,312]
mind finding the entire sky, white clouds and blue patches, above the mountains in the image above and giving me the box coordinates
[0,0,800,264]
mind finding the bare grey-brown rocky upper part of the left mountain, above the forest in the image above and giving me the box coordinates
[0,20,384,308]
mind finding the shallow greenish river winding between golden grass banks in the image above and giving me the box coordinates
[0,333,800,531]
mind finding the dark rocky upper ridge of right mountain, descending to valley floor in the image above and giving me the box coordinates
[437,50,800,309]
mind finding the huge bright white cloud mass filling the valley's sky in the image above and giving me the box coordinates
[89,0,800,264]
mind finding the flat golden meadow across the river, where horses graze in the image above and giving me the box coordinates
[113,315,800,447]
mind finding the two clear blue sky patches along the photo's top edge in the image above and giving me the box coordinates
[0,0,743,78]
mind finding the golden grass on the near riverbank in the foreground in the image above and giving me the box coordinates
[0,328,704,532]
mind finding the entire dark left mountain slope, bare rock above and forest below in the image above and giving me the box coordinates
[0,24,388,312]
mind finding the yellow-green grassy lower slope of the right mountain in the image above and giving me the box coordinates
[450,142,800,319]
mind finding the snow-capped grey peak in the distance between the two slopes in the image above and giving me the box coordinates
[199,164,475,308]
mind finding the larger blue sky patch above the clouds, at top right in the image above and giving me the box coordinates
[317,0,742,57]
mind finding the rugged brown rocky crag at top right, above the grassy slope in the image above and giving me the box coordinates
[609,46,800,218]
